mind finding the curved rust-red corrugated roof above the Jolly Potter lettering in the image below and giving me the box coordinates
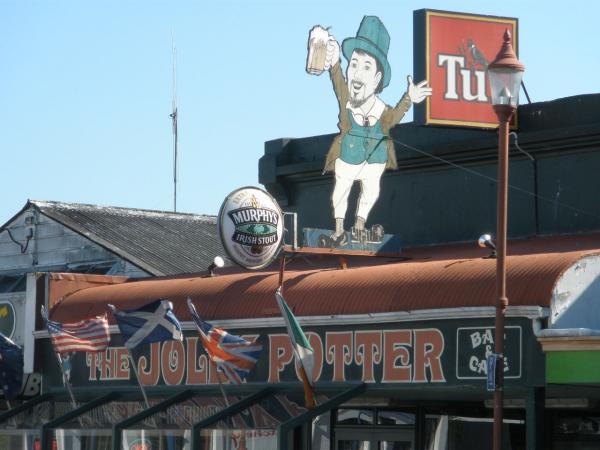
[52,235,600,321]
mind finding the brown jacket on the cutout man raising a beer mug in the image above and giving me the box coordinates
[323,62,412,173]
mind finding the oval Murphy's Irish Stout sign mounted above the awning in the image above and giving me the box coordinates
[218,187,283,269]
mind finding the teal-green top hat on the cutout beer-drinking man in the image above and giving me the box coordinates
[342,16,392,87]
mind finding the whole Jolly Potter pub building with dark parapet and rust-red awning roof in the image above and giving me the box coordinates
[0,95,600,450]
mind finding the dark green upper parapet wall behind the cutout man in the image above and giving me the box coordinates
[259,94,600,247]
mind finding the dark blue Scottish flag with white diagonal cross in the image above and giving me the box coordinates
[108,300,183,349]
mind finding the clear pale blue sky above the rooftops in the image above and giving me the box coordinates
[0,0,600,224]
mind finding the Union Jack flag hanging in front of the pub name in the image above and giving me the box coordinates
[188,298,262,384]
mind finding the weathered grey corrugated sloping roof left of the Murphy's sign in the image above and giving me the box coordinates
[24,200,225,276]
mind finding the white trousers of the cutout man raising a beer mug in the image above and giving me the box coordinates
[331,158,385,222]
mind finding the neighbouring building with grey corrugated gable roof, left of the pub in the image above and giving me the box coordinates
[0,200,223,398]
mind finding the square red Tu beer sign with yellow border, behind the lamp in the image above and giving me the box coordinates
[414,10,518,128]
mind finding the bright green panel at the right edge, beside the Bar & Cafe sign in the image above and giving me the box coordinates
[546,351,600,384]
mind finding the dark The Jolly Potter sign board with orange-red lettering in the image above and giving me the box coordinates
[44,319,543,389]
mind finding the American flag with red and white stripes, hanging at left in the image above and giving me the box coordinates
[46,314,110,353]
